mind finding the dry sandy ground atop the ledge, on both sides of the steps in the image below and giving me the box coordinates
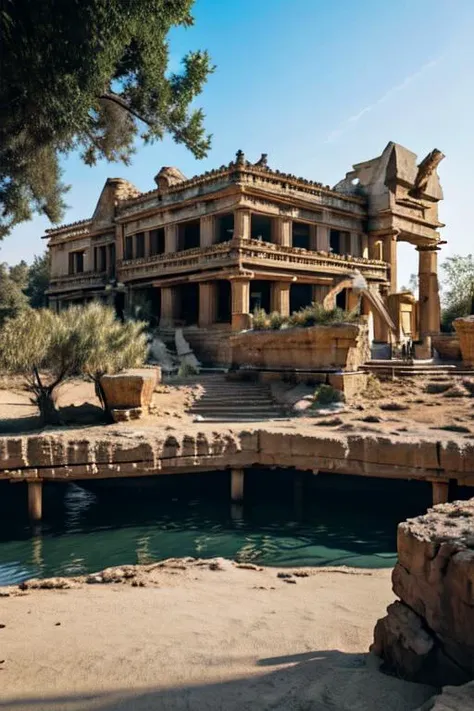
[0,375,474,439]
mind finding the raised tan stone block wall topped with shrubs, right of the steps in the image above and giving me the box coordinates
[231,323,370,371]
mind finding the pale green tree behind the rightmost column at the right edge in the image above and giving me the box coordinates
[441,254,474,331]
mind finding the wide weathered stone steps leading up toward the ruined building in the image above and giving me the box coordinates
[174,373,286,422]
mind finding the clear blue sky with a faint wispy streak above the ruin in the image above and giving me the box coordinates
[0,0,474,283]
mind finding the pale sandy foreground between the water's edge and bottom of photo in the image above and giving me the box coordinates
[0,560,433,711]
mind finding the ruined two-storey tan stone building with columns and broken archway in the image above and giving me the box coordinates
[46,143,443,361]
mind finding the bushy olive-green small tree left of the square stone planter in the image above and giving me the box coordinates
[0,304,146,425]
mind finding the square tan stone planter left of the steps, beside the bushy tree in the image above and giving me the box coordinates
[100,367,161,421]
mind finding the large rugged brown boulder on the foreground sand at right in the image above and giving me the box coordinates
[372,499,474,686]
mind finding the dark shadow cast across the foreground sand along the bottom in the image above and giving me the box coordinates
[0,650,435,711]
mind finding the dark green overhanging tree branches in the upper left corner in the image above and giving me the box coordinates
[0,0,213,239]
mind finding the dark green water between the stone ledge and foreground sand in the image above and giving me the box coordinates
[0,471,431,585]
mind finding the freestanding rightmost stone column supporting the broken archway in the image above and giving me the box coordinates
[417,245,441,338]
